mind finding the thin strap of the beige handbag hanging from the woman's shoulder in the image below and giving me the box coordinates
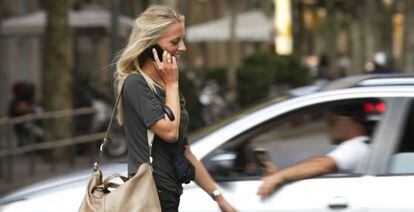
[93,72,155,171]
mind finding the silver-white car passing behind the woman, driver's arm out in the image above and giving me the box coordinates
[0,73,414,212]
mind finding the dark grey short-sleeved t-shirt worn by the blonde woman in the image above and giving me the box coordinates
[122,74,188,194]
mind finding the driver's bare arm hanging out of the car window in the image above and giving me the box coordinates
[257,156,338,198]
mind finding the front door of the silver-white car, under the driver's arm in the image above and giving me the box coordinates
[202,98,387,211]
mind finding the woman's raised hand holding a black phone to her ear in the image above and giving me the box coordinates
[152,49,179,87]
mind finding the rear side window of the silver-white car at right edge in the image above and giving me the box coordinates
[388,100,414,174]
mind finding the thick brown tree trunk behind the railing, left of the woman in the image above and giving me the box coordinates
[42,0,72,162]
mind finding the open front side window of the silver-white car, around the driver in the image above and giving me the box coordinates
[203,99,386,180]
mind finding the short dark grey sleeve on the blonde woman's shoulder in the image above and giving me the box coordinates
[123,74,164,128]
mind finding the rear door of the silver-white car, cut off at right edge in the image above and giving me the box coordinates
[363,97,414,212]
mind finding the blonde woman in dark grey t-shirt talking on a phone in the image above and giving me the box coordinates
[115,5,235,211]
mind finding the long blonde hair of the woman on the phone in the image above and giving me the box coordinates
[114,5,184,125]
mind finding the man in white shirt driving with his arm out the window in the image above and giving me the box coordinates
[257,104,369,198]
